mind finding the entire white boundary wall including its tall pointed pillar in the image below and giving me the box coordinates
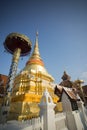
[0,91,87,130]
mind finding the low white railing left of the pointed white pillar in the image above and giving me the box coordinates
[0,117,43,130]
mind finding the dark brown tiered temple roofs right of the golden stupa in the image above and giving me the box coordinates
[54,71,87,105]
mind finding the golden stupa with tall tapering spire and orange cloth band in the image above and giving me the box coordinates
[9,33,59,120]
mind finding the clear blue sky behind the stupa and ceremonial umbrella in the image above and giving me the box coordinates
[0,0,87,84]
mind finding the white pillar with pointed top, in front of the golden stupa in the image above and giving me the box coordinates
[39,90,55,130]
